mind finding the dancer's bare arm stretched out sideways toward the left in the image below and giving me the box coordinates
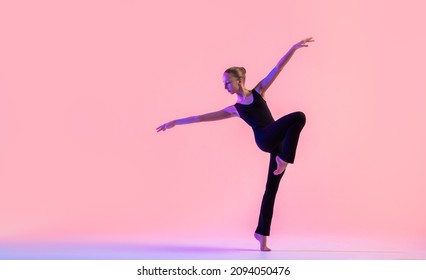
[157,105,238,132]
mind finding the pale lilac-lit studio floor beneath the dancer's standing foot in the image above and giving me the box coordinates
[0,237,426,260]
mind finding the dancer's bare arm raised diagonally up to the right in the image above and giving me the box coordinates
[255,37,314,97]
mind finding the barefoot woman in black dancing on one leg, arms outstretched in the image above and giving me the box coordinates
[157,37,314,251]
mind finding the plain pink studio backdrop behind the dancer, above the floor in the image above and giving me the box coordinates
[0,0,426,245]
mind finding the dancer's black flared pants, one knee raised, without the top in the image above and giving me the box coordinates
[255,112,306,236]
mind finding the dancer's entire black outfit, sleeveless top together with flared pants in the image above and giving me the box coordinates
[235,89,306,236]
